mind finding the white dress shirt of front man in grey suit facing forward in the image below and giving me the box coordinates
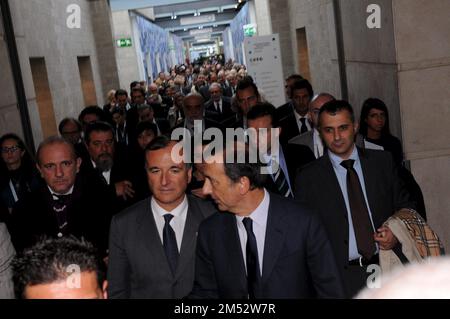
[151,196,189,252]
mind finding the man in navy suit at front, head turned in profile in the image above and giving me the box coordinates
[190,142,343,299]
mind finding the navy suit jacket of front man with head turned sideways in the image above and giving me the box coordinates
[190,194,343,299]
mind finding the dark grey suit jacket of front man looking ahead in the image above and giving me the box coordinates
[108,196,216,298]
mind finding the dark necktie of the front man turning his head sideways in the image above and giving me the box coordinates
[242,217,260,299]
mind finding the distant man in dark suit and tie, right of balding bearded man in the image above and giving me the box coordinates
[205,83,236,125]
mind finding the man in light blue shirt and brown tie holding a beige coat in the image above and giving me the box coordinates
[296,101,415,297]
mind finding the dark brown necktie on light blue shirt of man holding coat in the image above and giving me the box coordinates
[341,160,376,260]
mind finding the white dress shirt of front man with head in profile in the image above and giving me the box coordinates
[236,189,270,276]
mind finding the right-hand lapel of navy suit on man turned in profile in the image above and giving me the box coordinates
[262,196,287,283]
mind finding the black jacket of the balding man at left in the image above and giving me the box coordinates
[10,175,111,254]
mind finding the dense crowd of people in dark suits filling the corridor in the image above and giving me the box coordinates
[1,58,430,299]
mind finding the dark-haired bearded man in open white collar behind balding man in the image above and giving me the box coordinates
[81,122,134,213]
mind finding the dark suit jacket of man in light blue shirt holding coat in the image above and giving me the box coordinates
[295,148,415,297]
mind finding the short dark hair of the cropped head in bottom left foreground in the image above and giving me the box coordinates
[12,237,105,298]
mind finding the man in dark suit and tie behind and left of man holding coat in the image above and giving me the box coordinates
[278,79,314,144]
